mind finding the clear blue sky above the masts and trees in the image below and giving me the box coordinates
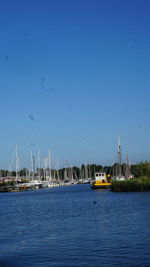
[0,0,150,169]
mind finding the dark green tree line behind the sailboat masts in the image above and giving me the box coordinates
[0,161,150,180]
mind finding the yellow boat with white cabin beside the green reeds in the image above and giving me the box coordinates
[91,172,111,189]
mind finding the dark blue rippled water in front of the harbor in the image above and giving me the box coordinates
[0,185,150,267]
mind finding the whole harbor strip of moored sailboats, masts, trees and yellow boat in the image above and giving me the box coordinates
[0,133,150,193]
